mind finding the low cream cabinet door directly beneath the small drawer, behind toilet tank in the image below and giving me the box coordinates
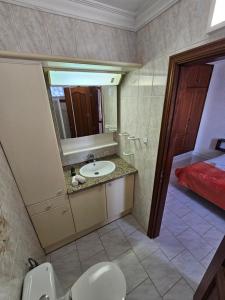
[31,204,75,248]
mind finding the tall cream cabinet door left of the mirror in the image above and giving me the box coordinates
[0,63,65,205]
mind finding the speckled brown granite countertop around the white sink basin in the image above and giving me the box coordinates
[64,155,137,194]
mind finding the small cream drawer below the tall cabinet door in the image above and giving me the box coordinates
[27,195,69,216]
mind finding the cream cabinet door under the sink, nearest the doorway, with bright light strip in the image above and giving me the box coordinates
[106,175,134,219]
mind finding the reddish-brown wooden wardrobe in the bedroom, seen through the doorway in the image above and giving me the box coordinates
[173,65,213,155]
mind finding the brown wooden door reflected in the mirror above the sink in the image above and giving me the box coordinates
[64,87,102,137]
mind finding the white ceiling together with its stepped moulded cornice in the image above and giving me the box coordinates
[4,0,180,31]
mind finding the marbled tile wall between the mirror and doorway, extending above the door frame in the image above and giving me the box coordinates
[120,0,225,229]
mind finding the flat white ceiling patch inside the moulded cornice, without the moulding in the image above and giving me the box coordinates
[92,0,150,13]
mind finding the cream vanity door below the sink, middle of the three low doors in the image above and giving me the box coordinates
[69,185,106,232]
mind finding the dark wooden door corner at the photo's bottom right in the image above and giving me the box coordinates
[194,237,225,300]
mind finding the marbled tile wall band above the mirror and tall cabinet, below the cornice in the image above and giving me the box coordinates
[0,1,136,62]
